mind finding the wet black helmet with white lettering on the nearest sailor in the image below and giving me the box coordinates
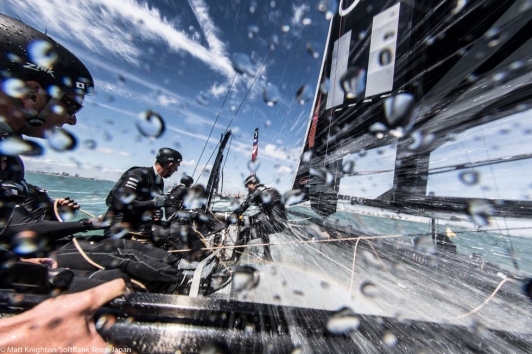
[0,14,94,126]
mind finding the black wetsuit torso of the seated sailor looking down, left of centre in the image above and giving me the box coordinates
[105,167,164,238]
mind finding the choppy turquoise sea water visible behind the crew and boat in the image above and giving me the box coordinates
[26,172,532,276]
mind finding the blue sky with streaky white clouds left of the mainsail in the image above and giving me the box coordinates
[0,0,329,193]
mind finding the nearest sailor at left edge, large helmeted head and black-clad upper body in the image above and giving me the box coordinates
[0,14,98,238]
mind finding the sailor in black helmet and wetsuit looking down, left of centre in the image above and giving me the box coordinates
[105,148,183,240]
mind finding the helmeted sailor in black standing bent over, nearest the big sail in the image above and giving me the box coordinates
[232,176,287,262]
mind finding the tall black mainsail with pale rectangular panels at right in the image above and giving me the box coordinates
[293,0,532,218]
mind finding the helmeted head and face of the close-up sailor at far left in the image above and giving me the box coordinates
[0,14,94,138]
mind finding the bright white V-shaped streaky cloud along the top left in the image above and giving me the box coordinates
[2,0,234,78]
